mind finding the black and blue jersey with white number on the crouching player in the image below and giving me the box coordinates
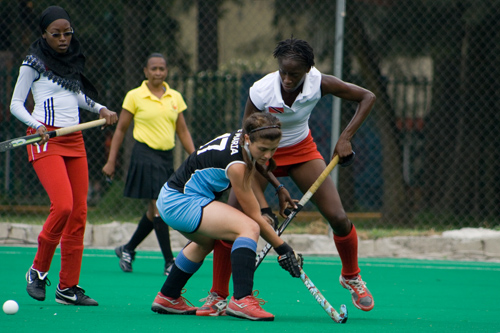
[168,129,245,199]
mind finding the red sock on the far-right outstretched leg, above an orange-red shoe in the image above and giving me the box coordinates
[333,224,361,279]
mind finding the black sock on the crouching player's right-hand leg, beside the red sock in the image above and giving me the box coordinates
[231,247,256,300]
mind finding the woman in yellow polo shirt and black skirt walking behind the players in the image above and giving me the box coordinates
[102,53,195,275]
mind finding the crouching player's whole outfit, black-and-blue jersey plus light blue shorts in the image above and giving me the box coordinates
[156,130,245,233]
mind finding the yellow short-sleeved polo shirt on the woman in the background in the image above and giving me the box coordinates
[122,80,187,150]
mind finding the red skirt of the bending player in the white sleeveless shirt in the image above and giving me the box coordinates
[273,131,323,177]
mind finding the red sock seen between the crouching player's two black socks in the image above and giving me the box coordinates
[210,240,233,298]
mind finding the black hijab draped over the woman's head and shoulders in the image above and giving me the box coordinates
[25,6,98,100]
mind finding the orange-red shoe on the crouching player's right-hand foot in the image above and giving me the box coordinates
[226,290,274,321]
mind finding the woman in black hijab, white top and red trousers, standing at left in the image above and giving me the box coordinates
[11,6,118,305]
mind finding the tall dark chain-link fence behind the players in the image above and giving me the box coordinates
[0,0,500,229]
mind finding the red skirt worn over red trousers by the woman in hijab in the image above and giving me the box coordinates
[26,125,87,162]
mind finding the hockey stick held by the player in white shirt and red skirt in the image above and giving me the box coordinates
[255,152,355,269]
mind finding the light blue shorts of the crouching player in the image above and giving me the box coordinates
[156,184,213,234]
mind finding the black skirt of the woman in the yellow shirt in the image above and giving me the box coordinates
[123,141,174,200]
